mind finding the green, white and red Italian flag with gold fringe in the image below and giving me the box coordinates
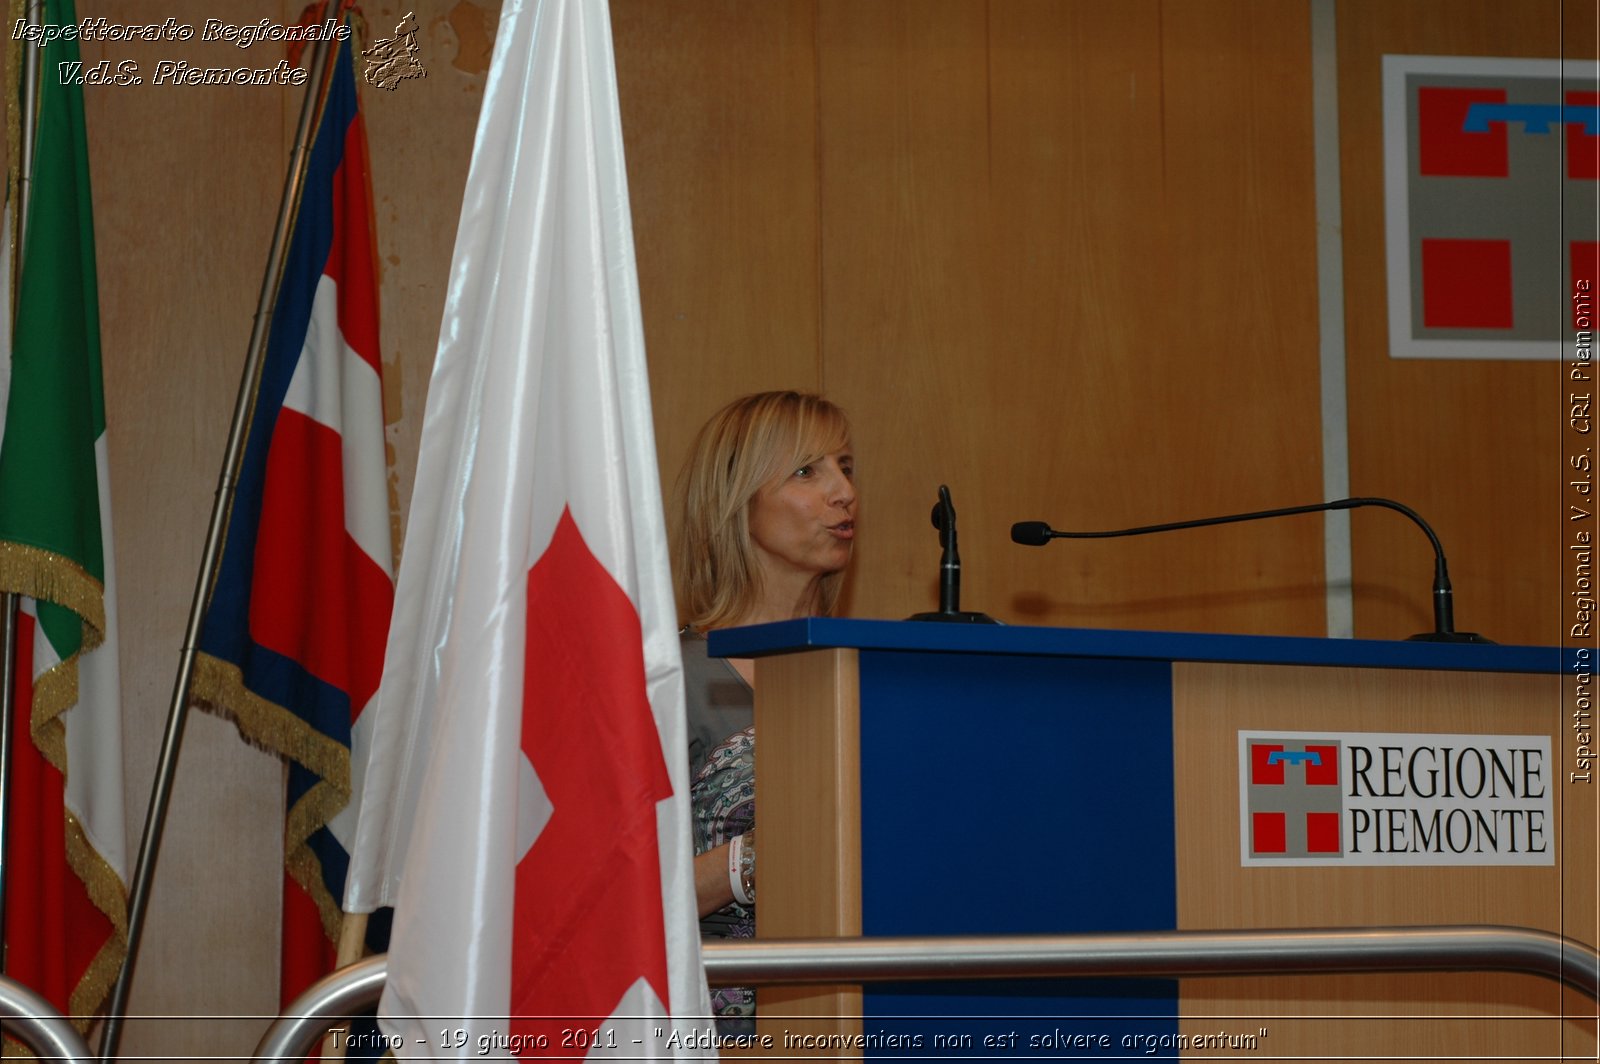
[0,0,128,1030]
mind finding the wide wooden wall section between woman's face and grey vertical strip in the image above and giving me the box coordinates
[819,0,1323,634]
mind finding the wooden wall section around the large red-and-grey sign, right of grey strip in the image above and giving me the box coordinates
[1338,0,1595,643]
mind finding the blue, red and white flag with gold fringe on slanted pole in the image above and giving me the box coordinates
[194,29,394,1002]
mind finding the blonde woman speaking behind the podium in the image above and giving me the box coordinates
[674,392,856,1019]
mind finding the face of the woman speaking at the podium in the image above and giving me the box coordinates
[750,443,856,579]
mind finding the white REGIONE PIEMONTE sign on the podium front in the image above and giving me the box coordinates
[1238,731,1558,867]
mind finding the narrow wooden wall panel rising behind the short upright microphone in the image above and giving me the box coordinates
[818,0,998,618]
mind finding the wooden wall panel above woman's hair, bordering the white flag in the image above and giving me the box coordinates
[611,0,822,491]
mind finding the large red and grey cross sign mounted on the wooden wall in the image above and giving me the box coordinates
[1384,56,1600,360]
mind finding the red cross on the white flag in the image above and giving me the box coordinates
[510,510,672,1056]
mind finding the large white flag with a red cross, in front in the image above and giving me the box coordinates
[346,0,709,1059]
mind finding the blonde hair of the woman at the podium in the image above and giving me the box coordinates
[672,392,850,629]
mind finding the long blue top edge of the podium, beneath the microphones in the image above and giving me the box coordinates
[709,618,1578,674]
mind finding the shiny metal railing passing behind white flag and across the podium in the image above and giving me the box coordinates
[254,925,1600,1064]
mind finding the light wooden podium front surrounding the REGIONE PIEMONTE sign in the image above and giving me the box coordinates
[1173,662,1597,1059]
